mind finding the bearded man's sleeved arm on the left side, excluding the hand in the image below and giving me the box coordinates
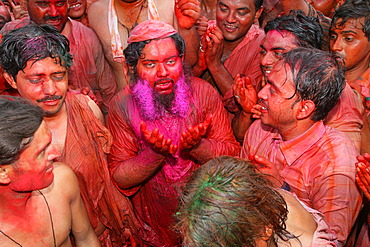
[107,94,171,190]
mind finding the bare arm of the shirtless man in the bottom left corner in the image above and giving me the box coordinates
[59,165,101,247]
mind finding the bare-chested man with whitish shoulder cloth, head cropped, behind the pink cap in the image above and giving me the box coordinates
[88,0,200,89]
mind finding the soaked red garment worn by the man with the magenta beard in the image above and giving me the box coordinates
[107,77,240,246]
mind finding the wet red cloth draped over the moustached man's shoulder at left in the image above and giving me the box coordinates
[58,93,139,246]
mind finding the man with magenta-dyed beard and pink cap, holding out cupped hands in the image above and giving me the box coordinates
[107,20,240,246]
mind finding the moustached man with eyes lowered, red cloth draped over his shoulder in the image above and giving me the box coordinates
[0,24,137,246]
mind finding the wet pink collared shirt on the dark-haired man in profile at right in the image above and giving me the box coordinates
[241,120,362,244]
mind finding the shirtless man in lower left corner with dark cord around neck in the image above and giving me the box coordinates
[0,96,100,247]
